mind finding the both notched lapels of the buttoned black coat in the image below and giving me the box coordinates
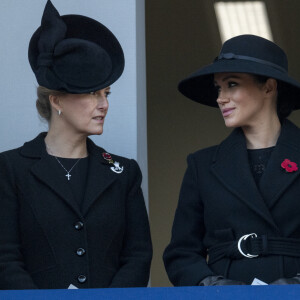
[20,132,120,216]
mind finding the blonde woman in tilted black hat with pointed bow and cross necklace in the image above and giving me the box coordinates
[0,1,152,289]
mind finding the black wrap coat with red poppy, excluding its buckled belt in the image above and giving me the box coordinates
[164,120,300,285]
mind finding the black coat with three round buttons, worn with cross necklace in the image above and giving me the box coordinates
[0,134,152,289]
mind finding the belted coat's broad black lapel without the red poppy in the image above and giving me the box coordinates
[211,128,277,228]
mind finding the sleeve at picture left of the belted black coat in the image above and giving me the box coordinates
[163,155,215,286]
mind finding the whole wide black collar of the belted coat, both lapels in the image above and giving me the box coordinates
[211,120,300,230]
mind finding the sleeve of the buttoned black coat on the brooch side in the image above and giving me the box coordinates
[110,160,152,287]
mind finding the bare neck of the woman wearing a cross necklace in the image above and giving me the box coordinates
[45,129,88,158]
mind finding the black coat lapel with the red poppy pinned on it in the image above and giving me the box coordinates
[260,120,300,208]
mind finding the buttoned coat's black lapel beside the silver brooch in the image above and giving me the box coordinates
[82,139,119,215]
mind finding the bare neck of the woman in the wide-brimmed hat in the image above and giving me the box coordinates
[242,117,281,149]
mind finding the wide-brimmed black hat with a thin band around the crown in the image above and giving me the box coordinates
[178,34,300,109]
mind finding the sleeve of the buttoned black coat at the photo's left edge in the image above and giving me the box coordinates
[0,153,37,290]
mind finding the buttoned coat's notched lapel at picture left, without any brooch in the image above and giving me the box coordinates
[21,133,81,216]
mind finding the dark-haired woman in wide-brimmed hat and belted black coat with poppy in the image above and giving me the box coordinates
[164,35,300,286]
